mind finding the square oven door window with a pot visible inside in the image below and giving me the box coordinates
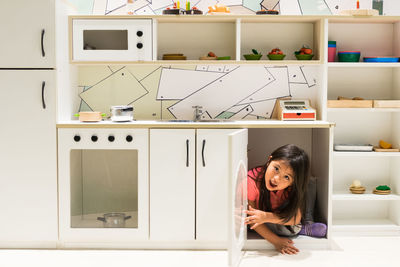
[70,149,139,228]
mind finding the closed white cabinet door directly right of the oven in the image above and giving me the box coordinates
[150,129,195,241]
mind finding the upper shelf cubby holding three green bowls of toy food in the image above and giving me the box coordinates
[240,18,323,63]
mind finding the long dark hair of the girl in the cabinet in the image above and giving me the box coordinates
[256,144,310,223]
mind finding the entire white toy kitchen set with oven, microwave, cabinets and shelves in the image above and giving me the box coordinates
[4,0,400,265]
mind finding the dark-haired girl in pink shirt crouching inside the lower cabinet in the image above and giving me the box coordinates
[245,145,310,254]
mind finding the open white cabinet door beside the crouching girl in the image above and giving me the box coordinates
[228,129,248,267]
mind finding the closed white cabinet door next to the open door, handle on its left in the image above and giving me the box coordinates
[196,129,247,242]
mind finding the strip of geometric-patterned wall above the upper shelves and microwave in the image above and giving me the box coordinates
[64,0,400,16]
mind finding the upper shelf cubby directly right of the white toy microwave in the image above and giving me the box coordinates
[157,20,236,60]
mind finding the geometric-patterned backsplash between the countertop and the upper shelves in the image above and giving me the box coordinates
[77,65,319,120]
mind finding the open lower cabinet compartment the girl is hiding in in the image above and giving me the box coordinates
[247,128,332,248]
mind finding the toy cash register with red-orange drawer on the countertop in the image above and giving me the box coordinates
[277,100,317,121]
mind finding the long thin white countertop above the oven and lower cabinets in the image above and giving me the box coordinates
[57,120,335,128]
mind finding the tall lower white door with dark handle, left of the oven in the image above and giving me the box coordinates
[0,70,57,247]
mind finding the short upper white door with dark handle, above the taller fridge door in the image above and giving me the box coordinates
[0,0,55,68]
